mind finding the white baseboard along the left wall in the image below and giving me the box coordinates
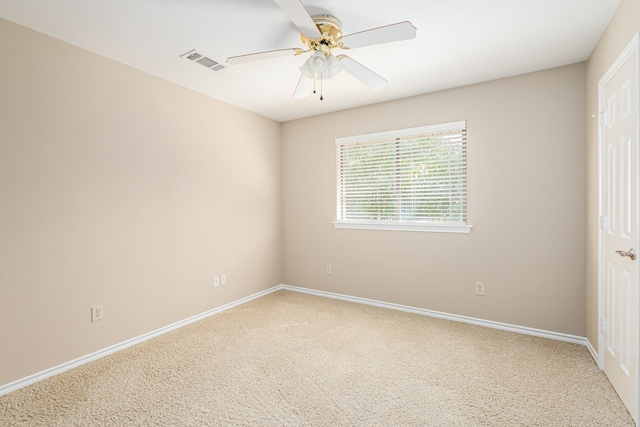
[0,285,282,396]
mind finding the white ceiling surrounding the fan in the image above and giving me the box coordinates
[0,0,620,121]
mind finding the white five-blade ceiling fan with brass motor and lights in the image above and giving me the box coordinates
[227,0,416,100]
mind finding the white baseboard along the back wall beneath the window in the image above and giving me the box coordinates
[281,285,588,346]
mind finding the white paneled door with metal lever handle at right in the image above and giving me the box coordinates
[599,33,640,422]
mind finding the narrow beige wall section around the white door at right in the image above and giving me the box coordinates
[586,0,640,349]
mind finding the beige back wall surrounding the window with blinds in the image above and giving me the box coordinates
[283,64,585,336]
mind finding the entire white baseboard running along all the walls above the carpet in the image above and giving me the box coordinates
[0,285,598,396]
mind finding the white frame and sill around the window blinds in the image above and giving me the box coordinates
[333,120,472,233]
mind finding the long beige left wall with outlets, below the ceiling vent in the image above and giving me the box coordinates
[0,20,282,385]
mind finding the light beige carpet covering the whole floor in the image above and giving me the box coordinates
[0,291,633,427]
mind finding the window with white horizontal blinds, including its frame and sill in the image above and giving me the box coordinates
[334,121,471,233]
